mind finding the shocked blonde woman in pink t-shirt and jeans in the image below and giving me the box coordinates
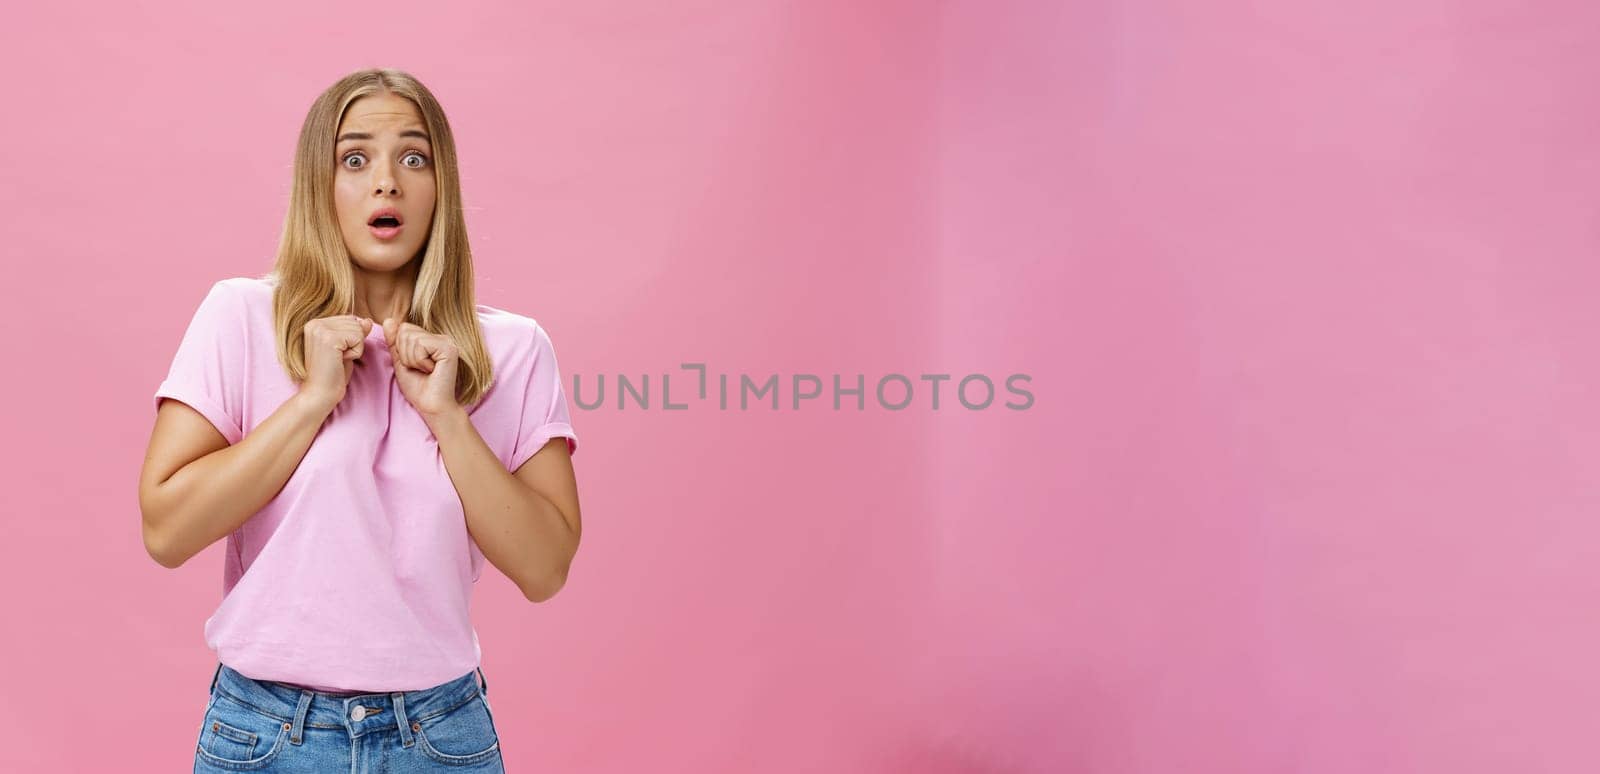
[139,69,581,772]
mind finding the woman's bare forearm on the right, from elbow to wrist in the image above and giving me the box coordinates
[426,408,578,601]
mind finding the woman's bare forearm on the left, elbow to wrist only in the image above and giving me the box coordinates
[144,393,333,568]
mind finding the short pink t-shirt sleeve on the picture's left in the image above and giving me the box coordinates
[155,280,245,445]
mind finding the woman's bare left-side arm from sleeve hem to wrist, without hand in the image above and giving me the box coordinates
[139,390,338,568]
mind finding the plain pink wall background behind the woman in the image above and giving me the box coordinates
[0,0,1600,774]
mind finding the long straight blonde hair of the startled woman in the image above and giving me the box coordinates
[264,67,494,405]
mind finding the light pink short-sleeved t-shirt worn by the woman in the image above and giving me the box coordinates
[155,277,578,691]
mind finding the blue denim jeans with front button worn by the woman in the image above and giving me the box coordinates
[194,664,506,774]
